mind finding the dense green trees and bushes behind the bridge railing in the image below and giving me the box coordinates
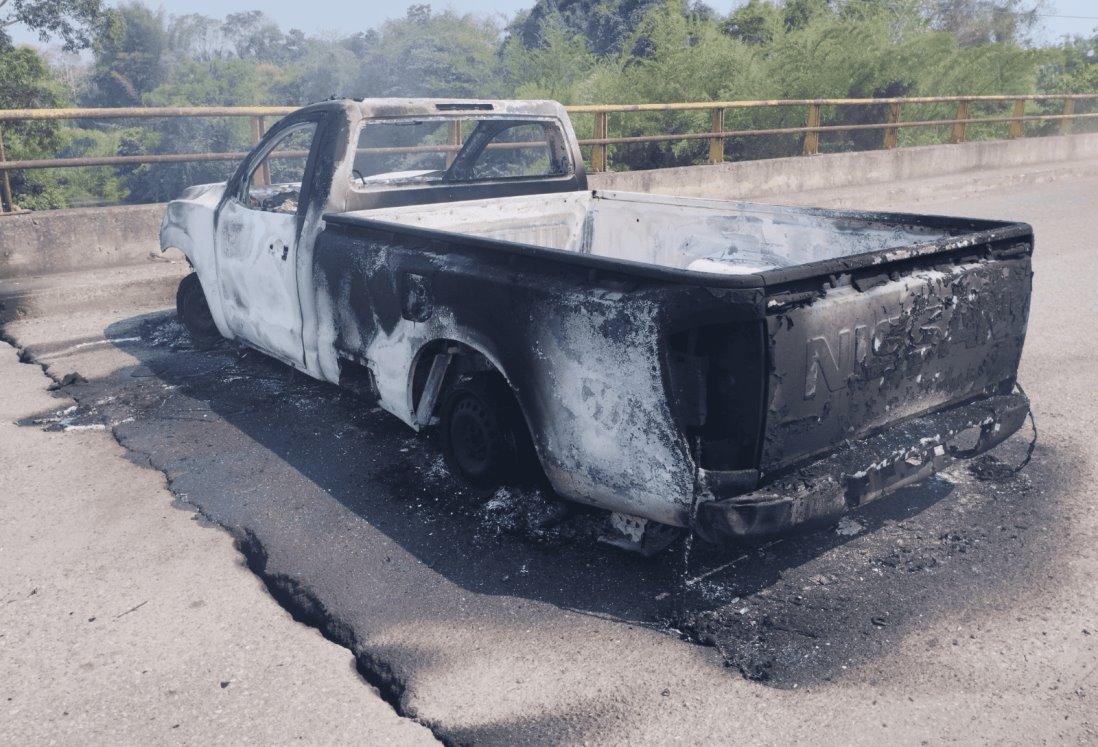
[0,0,1098,208]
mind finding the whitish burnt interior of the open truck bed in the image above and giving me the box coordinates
[348,191,993,275]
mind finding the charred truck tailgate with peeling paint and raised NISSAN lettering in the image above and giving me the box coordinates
[760,224,1032,476]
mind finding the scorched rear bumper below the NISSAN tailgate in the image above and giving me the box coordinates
[695,394,1029,543]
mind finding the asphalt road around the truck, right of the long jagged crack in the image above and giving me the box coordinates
[7,172,1098,745]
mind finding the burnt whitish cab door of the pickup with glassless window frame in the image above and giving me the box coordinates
[216,120,317,368]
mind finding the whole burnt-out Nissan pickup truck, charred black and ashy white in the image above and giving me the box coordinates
[161,100,1033,549]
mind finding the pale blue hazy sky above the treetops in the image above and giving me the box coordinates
[10,0,1098,44]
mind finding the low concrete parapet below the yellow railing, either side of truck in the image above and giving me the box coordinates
[0,134,1098,279]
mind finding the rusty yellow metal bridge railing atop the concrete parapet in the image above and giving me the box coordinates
[0,93,1098,212]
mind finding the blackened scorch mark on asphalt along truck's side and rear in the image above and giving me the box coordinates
[17,305,1074,700]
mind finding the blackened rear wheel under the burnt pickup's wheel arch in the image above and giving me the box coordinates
[439,376,528,488]
